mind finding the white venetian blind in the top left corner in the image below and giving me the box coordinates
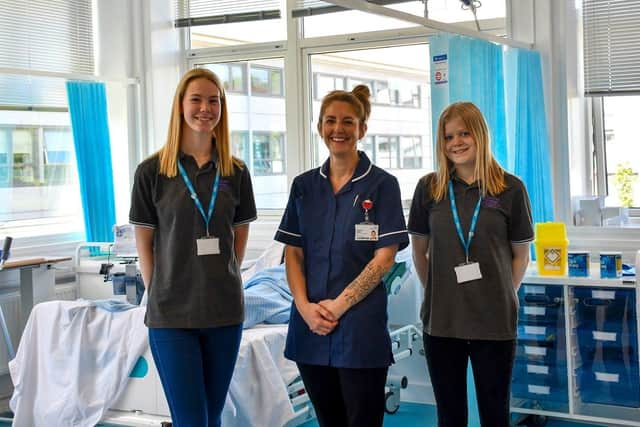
[0,0,94,107]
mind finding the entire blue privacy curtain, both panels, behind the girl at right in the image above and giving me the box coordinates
[429,33,553,226]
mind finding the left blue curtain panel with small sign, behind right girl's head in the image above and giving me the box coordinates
[429,33,508,167]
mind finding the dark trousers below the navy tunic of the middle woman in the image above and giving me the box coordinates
[298,363,388,427]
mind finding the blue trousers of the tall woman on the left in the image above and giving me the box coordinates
[149,324,242,427]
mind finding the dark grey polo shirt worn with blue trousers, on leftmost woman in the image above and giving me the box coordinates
[129,154,256,328]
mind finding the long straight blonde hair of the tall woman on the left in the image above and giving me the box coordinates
[157,68,244,178]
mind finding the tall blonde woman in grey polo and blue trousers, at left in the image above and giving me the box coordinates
[129,68,256,427]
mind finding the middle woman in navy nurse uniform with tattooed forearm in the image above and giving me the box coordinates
[275,85,408,427]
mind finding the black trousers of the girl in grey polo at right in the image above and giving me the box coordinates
[423,334,516,427]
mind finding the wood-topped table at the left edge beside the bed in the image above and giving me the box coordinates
[0,257,71,331]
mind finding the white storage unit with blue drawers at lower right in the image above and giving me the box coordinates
[511,265,640,427]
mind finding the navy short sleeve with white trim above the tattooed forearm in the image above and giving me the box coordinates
[374,175,409,250]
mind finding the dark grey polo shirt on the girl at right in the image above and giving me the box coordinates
[408,173,533,340]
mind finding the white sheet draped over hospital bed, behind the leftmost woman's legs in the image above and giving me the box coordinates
[9,300,298,427]
